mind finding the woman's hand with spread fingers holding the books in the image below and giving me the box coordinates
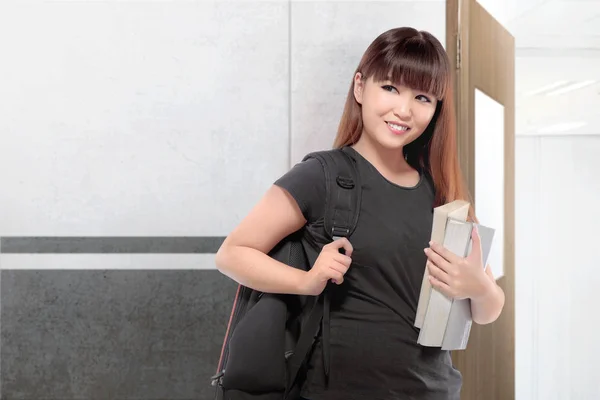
[425,227,493,299]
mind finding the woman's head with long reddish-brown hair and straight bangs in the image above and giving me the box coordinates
[334,28,475,219]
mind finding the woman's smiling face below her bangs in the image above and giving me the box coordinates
[354,73,437,150]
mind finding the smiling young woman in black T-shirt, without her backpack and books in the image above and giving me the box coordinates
[217,28,504,400]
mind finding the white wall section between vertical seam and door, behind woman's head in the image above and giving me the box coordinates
[291,0,446,164]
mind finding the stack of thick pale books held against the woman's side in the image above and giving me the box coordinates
[414,200,495,350]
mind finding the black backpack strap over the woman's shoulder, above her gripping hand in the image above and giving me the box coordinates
[304,147,362,240]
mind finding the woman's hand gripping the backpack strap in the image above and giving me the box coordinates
[301,238,352,296]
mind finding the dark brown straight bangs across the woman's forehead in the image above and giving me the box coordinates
[365,37,449,100]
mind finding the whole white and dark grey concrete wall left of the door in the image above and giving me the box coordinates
[0,0,445,400]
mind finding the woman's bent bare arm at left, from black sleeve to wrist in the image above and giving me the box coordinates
[216,185,306,294]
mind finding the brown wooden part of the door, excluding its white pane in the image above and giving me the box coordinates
[446,0,515,400]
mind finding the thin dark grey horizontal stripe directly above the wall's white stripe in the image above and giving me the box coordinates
[0,236,225,254]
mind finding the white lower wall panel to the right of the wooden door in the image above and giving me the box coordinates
[516,135,600,400]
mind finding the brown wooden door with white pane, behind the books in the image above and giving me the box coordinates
[446,0,515,400]
